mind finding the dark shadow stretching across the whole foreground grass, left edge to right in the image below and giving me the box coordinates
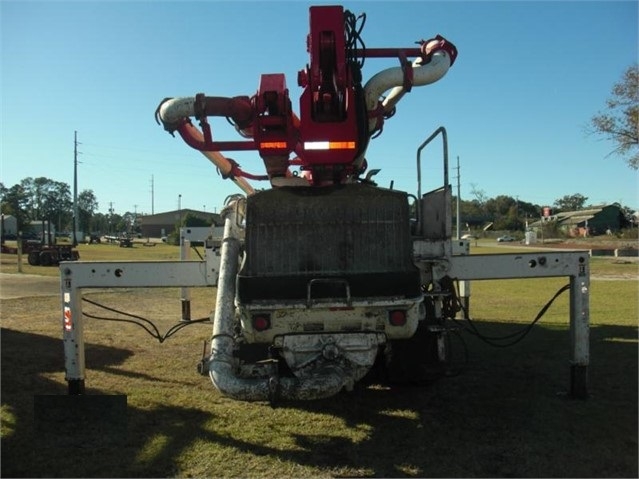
[2,322,638,477]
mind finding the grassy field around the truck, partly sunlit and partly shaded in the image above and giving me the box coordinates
[1,245,639,478]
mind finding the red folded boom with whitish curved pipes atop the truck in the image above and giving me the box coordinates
[156,6,457,194]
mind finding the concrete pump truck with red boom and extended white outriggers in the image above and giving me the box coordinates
[60,6,589,401]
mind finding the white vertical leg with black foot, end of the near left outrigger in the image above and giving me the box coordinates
[61,270,84,395]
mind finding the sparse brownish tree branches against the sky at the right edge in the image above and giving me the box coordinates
[588,64,639,170]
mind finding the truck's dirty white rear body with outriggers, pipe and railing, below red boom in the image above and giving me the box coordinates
[60,128,590,402]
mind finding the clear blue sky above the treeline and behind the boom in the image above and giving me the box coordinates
[0,0,639,214]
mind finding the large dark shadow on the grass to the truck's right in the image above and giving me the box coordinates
[284,323,638,477]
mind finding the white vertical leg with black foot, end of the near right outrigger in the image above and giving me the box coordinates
[570,255,590,399]
